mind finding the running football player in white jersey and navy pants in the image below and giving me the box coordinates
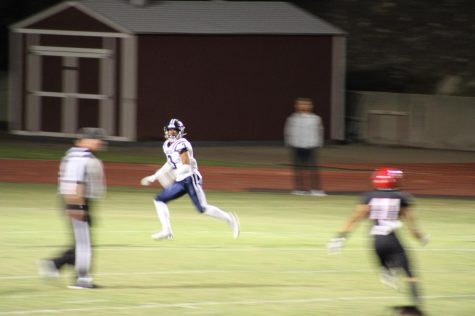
[141,119,240,240]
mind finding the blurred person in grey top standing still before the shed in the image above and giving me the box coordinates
[284,98,326,196]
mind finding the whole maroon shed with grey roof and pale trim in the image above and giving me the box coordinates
[9,0,346,141]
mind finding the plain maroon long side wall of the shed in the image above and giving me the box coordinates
[137,36,332,141]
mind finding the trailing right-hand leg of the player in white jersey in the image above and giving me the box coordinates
[184,175,240,238]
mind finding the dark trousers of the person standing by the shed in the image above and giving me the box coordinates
[291,147,321,191]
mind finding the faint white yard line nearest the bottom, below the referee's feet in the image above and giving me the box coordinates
[0,293,475,315]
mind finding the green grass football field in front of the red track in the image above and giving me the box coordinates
[0,183,475,316]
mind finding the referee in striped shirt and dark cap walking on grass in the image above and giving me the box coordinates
[40,127,106,289]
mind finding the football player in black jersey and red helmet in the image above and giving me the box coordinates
[328,168,428,312]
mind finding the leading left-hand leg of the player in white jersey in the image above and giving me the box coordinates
[152,181,186,240]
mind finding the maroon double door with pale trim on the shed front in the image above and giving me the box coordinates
[26,46,115,135]
